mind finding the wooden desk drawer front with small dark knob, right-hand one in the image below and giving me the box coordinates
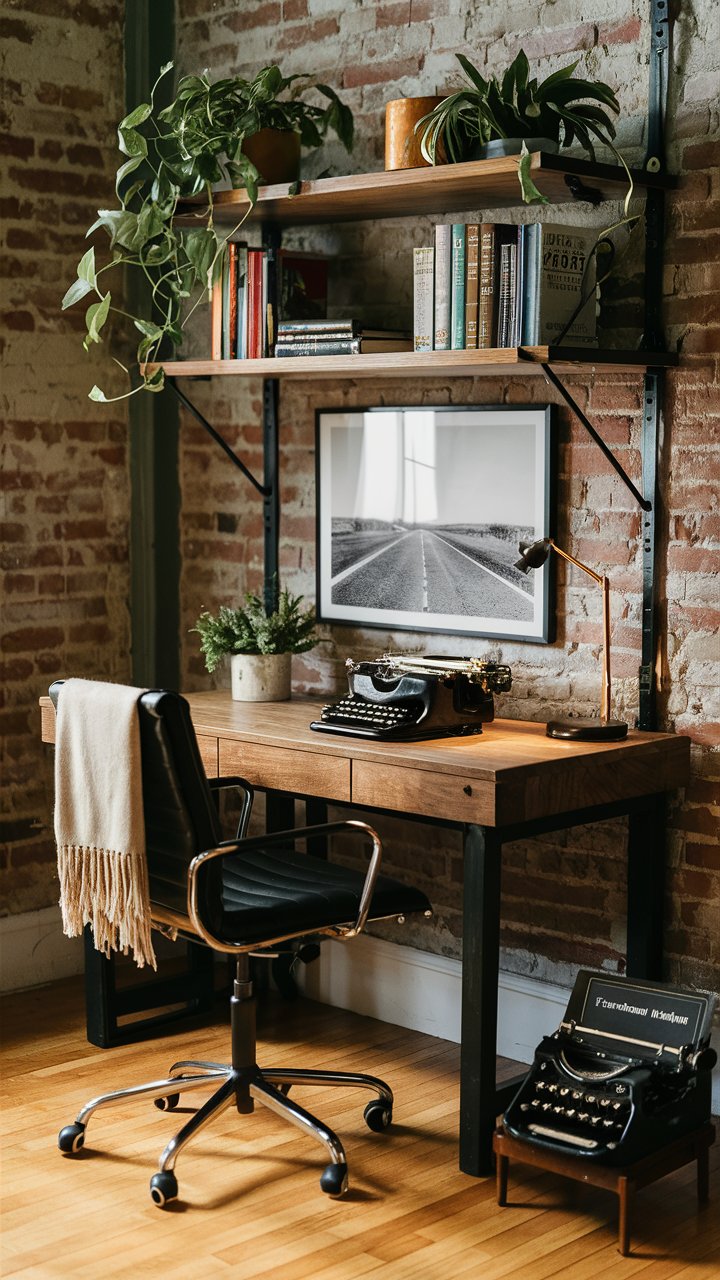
[352,760,495,827]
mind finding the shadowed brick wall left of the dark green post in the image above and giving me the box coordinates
[0,0,129,913]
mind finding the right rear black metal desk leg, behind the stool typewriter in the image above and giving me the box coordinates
[626,795,666,979]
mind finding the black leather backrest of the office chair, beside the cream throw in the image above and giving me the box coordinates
[50,680,222,915]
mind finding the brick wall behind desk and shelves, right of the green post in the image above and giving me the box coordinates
[178,0,720,989]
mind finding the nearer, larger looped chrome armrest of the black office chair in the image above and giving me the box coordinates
[187,818,383,954]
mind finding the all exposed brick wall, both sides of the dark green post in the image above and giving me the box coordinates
[0,0,720,989]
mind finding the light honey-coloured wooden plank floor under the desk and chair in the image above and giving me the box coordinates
[1,982,720,1280]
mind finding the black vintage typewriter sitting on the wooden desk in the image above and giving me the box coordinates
[310,653,512,741]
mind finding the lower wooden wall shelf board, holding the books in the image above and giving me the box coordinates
[146,347,678,379]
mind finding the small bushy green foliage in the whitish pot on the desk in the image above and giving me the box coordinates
[192,588,318,673]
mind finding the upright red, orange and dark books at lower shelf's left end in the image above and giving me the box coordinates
[210,241,328,360]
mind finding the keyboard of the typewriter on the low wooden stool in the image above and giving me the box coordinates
[519,1062,632,1151]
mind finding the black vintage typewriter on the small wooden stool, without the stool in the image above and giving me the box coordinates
[503,970,716,1165]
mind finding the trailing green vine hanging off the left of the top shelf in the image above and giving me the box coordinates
[63,63,354,401]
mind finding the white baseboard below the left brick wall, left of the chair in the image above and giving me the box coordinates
[0,906,83,992]
